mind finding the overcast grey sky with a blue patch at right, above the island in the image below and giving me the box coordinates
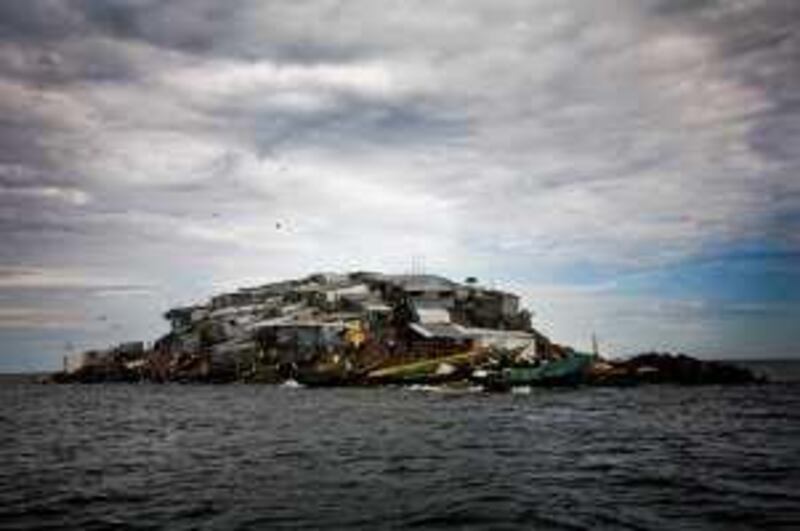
[0,0,800,370]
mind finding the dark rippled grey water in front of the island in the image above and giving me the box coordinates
[0,383,800,529]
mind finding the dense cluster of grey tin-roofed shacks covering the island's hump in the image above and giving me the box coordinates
[64,272,560,381]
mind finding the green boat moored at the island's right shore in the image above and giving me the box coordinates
[484,352,593,391]
